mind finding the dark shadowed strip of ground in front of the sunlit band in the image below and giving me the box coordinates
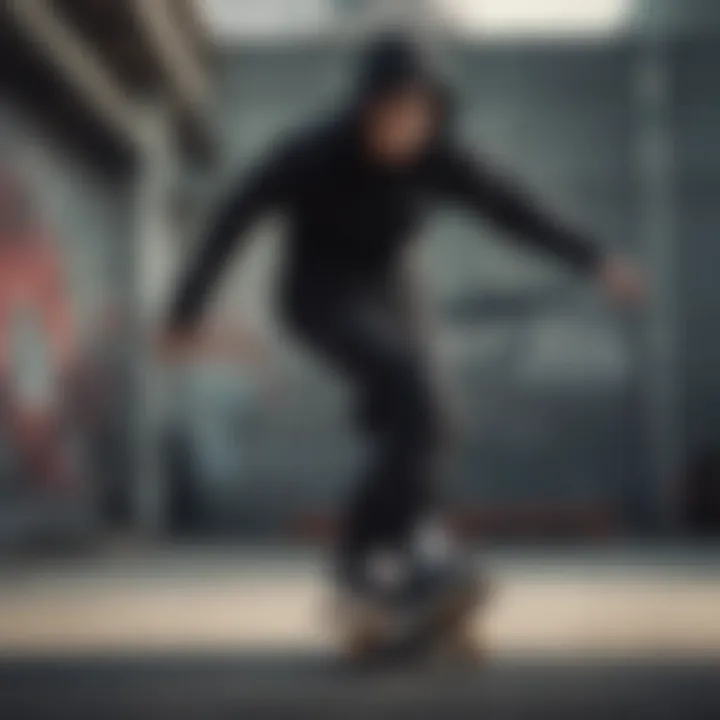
[0,652,720,720]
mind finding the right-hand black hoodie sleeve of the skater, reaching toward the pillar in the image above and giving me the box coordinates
[428,143,601,271]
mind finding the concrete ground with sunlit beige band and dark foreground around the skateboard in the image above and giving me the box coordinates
[0,547,720,719]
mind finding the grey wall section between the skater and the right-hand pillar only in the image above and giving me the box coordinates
[448,44,638,506]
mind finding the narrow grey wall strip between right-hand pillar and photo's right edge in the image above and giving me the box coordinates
[668,35,720,453]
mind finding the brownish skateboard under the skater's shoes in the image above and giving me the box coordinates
[334,581,490,664]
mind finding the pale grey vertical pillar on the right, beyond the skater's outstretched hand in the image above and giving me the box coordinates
[636,23,683,530]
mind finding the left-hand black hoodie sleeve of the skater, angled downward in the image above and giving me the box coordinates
[169,146,296,328]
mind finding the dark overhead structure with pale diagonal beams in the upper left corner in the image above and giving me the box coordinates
[0,0,211,173]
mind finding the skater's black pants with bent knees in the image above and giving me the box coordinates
[290,284,440,564]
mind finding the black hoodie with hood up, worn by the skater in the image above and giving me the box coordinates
[171,37,599,326]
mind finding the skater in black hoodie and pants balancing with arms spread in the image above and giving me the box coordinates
[170,36,638,608]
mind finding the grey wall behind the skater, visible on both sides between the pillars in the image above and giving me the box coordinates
[194,42,638,524]
